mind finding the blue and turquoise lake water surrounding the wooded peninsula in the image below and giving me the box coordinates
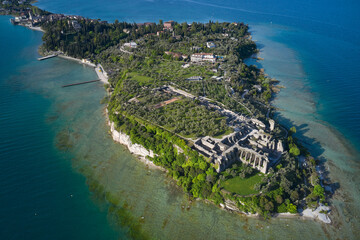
[0,0,360,239]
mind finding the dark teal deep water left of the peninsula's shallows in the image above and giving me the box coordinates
[0,16,119,239]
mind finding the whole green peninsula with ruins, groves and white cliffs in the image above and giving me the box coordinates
[0,0,330,222]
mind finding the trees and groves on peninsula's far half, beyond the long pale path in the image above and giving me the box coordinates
[42,19,272,117]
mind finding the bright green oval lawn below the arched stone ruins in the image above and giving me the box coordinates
[221,173,264,195]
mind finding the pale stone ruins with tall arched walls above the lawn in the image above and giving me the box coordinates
[194,121,284,173]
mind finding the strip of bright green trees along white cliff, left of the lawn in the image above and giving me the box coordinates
[110,111,222,202]
